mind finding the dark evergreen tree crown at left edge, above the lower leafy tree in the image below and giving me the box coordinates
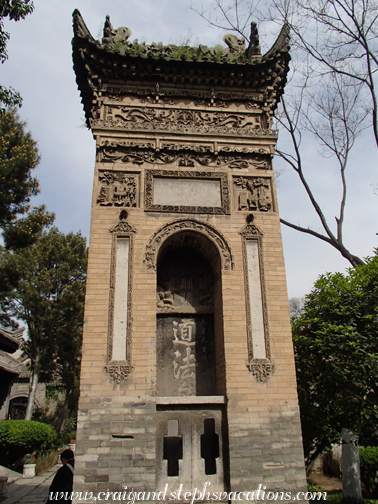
[0,111,39,227]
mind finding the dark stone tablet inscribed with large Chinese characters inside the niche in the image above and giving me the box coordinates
[156,315,216,396]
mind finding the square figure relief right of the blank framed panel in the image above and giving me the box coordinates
[234,177,272,212]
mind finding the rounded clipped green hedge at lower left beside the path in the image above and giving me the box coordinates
[0,420,58,465]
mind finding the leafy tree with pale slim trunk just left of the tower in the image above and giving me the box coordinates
[0,228,87,419]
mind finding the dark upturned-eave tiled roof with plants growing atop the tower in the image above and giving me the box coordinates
[72,10,290,126]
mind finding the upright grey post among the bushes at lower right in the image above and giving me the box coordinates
[341,427,363,504]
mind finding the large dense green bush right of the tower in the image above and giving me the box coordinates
[293,255,378,462]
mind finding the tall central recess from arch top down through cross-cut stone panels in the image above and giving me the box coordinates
[156,232,225,492]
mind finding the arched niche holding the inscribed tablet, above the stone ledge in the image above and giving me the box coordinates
[156,230,225,397]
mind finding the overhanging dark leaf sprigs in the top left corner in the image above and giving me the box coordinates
[0,0,34,113]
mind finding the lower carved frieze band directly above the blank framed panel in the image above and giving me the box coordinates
[98,141,270,171]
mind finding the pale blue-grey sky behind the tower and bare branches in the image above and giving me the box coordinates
[0,0,378,297]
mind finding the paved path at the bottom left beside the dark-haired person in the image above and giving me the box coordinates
[0,464,61,504]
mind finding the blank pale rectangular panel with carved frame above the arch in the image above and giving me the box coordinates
[145,170,230,214]
